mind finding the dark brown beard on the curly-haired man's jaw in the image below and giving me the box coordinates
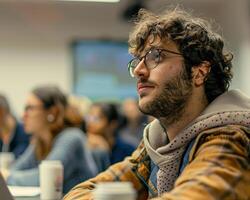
[139,68,192,124]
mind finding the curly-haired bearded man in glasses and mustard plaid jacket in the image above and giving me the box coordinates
[65,8,250,200]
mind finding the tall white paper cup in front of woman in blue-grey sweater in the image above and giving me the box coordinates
[39,160,63,200]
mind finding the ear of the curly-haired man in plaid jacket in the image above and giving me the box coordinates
[192,61,211,87]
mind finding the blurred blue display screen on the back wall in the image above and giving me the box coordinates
[73,40,136,101]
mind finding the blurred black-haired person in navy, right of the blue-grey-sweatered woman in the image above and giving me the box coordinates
[86,103,135,164]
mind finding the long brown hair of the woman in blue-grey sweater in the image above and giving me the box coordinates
[31,85,82,160]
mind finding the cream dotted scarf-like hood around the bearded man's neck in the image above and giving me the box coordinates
[143,90,250,196]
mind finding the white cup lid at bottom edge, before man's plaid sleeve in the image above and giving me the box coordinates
[93,182,136,200]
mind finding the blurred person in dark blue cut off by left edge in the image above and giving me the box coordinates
[0,94,30,158]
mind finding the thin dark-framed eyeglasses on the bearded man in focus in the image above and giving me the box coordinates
[128,49,182,77]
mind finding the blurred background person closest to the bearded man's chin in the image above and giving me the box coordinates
[119,98,148,147]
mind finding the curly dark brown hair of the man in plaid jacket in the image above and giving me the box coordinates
[129,7,233,102]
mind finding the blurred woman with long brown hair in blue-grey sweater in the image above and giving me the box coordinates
[5,86,97,193]
